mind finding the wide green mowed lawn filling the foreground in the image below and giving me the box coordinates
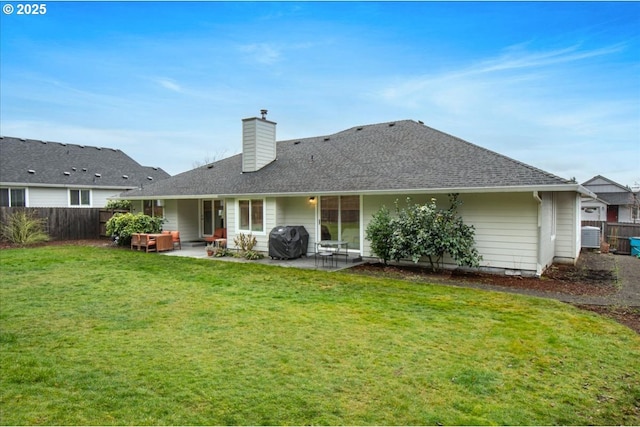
[0,246,640,425]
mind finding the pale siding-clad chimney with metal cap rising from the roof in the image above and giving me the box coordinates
[242,110,276,172]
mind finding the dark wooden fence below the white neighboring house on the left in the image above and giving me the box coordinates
[0,207,103,240]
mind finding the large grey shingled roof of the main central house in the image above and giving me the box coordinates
[121,120,577,199]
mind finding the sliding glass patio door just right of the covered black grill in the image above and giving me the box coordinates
[320,196,360,251]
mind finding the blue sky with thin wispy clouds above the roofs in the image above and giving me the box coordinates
[0,1,640,186]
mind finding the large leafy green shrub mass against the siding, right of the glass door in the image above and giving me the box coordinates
[367,194,482,270]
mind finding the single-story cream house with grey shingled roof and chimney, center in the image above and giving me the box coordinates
[121,113,593,274]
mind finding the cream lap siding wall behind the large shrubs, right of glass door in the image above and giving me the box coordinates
[363,193,538,271]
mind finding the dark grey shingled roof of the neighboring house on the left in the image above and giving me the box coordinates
[0,137,170,190]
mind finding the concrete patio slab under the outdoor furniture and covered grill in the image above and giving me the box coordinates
[159,242,364,271]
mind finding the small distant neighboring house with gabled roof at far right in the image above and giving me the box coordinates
[582,175,640,223]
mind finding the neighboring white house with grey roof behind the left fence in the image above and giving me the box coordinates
[0,137,170,208]
